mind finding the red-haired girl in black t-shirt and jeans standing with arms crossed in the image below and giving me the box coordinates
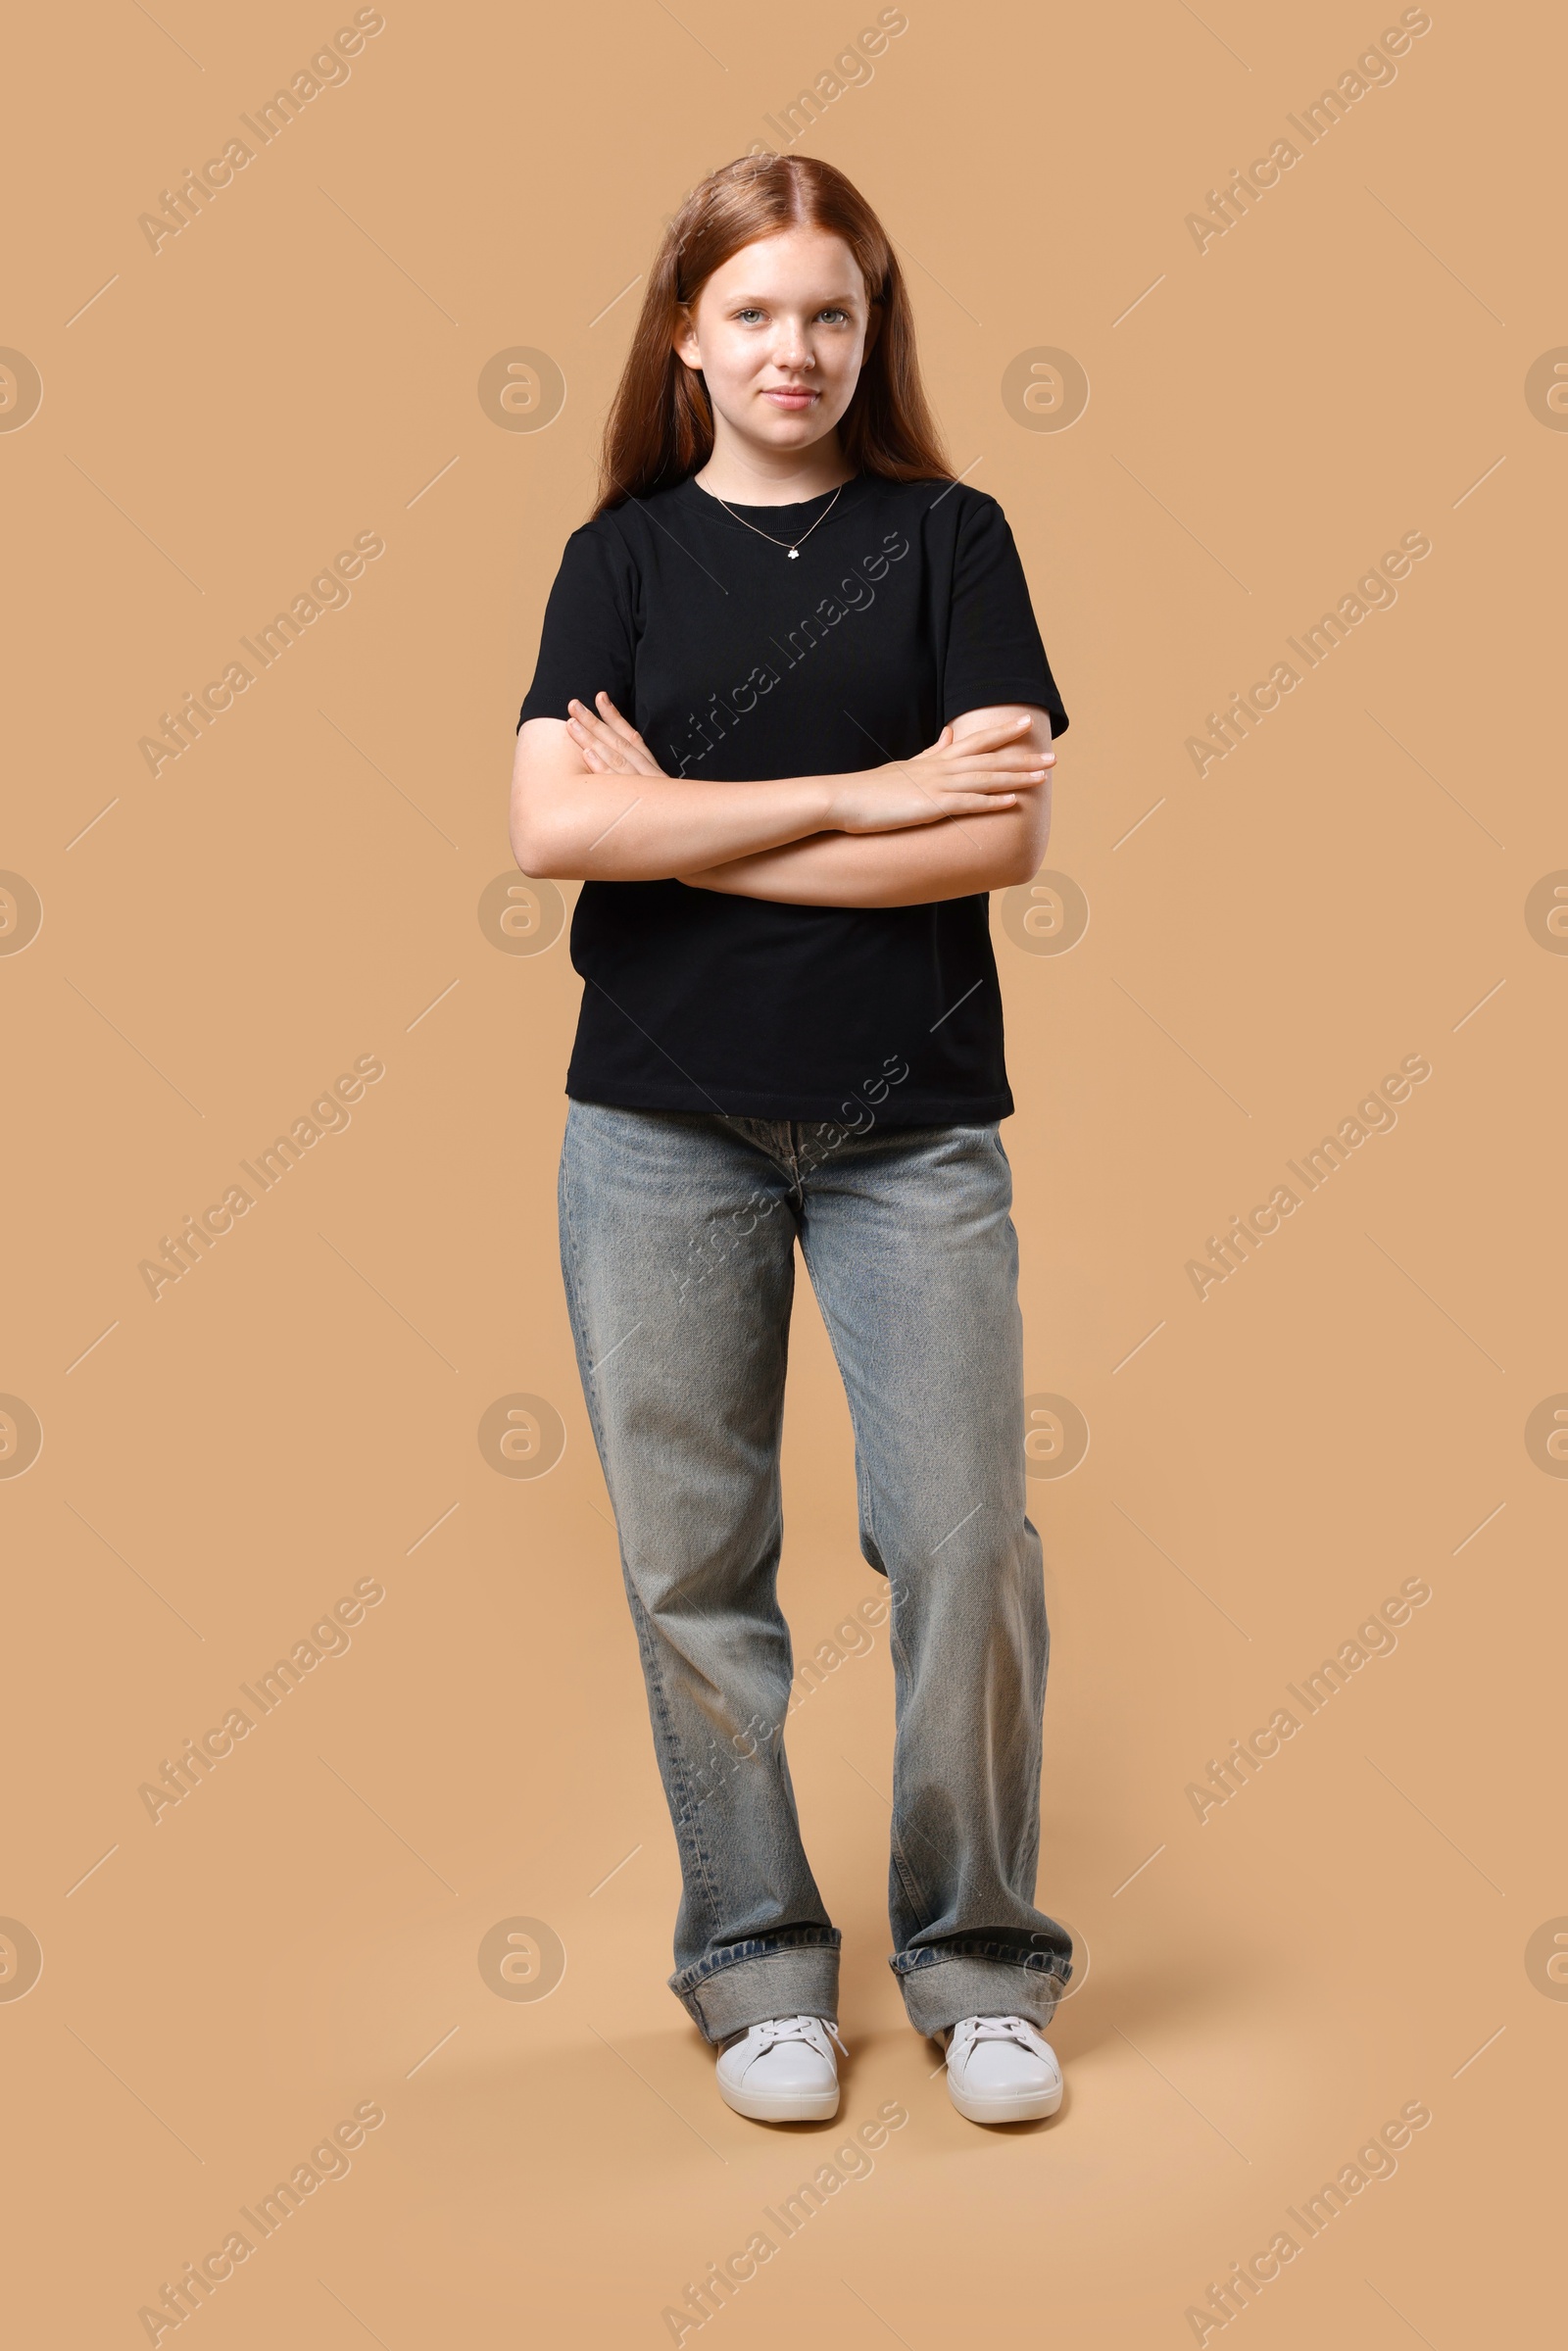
[513,155,1072,2123]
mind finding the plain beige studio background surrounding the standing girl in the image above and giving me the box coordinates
[0,0,1568,2351]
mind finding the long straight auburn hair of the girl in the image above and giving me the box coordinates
[595,155,953,514]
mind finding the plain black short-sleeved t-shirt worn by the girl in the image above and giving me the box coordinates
[517,472,1067,1126]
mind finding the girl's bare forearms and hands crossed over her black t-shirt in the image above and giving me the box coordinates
[513,696,1055,906]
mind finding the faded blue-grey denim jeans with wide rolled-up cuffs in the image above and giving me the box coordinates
[560,1101,1072,2040]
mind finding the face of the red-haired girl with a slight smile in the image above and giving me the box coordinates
[674,228,882,456]
